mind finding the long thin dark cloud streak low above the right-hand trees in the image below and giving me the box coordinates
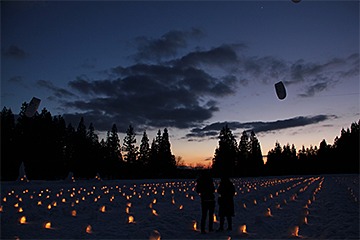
[186,115,336,141]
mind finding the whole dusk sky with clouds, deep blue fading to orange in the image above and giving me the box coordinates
[1,0,360,164]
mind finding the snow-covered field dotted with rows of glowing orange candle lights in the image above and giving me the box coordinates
[0,175,359,239]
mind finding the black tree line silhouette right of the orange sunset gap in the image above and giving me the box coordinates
[212,120,360,177]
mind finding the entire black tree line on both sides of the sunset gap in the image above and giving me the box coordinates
[1,102,360,181]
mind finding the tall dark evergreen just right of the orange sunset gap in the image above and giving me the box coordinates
[213,124,238,177]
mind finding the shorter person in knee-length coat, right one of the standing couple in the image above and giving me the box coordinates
[217,177,235,231]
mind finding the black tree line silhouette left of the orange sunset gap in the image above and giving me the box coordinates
[1,102,176,181]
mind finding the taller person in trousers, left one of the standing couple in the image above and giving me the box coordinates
[196,170,215,233]
